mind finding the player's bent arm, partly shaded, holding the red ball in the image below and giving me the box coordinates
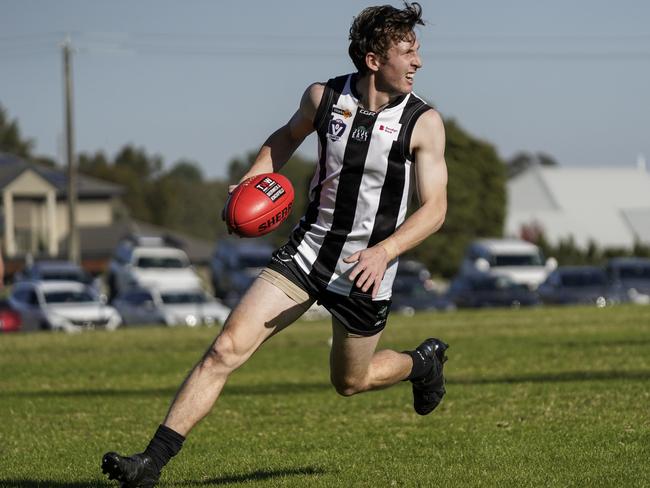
[234,83,325,182]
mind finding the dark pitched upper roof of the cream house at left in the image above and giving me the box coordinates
[0,153,124,198]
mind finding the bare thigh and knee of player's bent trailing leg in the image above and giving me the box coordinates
[330,317,381,380]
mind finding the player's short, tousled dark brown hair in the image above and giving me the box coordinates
[348,2,424,74]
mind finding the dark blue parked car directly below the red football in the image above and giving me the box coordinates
[210,239,274,307]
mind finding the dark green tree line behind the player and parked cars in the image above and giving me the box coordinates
[10,101,636,278]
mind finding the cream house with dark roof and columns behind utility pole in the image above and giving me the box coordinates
[0,153,214,274]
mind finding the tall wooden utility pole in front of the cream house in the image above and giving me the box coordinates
[63,37,81,264]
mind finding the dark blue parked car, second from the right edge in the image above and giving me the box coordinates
[537,266,612,307]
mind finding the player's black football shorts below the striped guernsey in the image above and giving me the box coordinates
[268,245,391,337]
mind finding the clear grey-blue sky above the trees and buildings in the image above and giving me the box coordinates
[0,0,650,178]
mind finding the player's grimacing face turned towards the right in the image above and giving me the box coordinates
[377,34,422,94]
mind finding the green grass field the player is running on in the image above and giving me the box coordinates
[0,307,650,488]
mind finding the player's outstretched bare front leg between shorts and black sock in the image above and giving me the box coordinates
[164,279,311,436]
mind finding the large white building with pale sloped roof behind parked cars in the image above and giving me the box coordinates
[506,165,650,248]
